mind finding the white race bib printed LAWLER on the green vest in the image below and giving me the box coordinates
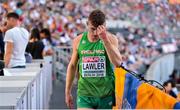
[82,56,106,77]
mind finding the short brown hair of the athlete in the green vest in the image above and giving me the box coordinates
[88,9,106,27]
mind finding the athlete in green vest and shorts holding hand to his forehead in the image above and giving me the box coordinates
[65,10,122,109]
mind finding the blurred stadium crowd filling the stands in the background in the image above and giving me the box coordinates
[0,0,180,98]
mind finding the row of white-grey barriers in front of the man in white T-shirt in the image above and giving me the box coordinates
[0,57,52,109]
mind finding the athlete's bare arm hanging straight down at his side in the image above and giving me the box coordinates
[65,35,82,108]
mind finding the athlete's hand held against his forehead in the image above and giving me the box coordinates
[97,25,108,41]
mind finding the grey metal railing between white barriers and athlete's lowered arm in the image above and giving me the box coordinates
[53,46,72,81]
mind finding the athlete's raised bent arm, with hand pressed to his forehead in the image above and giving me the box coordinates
[97,25,122,67]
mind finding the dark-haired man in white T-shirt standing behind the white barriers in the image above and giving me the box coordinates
[4,12,29,68]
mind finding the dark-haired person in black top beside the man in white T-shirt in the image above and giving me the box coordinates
[26,28,44,59]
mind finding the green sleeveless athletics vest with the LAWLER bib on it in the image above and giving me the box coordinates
[78,32,114,97]
